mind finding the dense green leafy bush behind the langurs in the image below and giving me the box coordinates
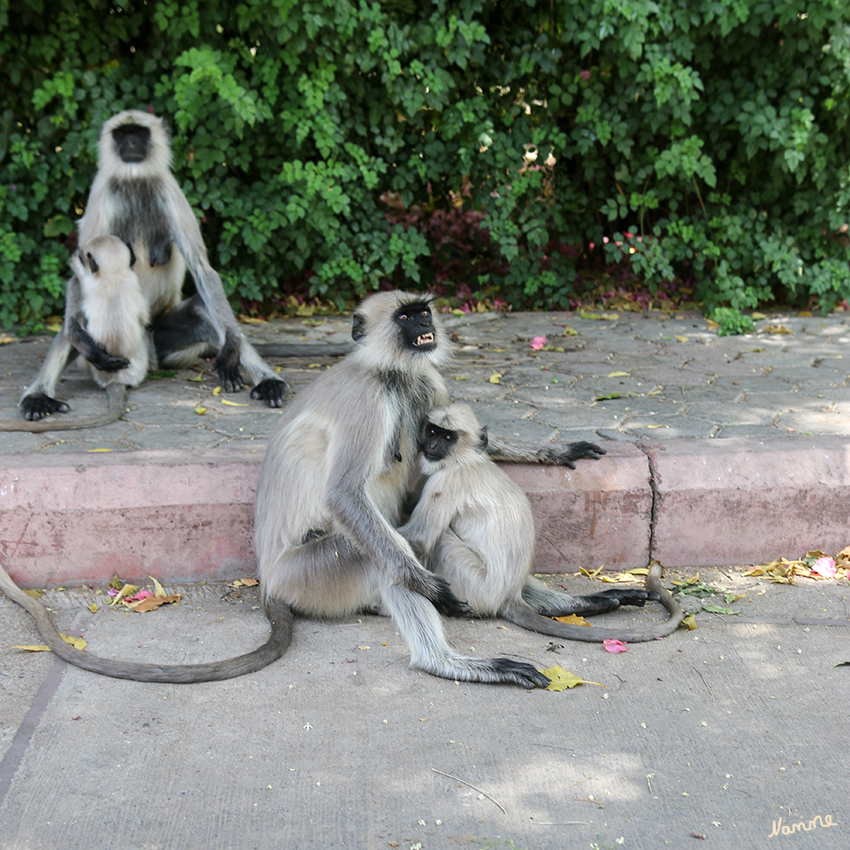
[0,0,850,326]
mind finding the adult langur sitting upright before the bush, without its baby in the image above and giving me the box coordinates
[20,109,287,421]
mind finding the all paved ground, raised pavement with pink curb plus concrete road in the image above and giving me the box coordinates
[0,314,850,850]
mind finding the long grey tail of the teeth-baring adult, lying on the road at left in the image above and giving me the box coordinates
[0,564,295,684]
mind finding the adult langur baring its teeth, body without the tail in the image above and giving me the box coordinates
[254,292,601,688]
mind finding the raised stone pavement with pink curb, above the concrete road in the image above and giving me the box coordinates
[0,313,850,586]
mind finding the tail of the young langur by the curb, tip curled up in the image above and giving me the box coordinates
[500,561,685,643]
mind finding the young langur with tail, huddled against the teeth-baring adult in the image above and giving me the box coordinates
[399,404,684,642]
